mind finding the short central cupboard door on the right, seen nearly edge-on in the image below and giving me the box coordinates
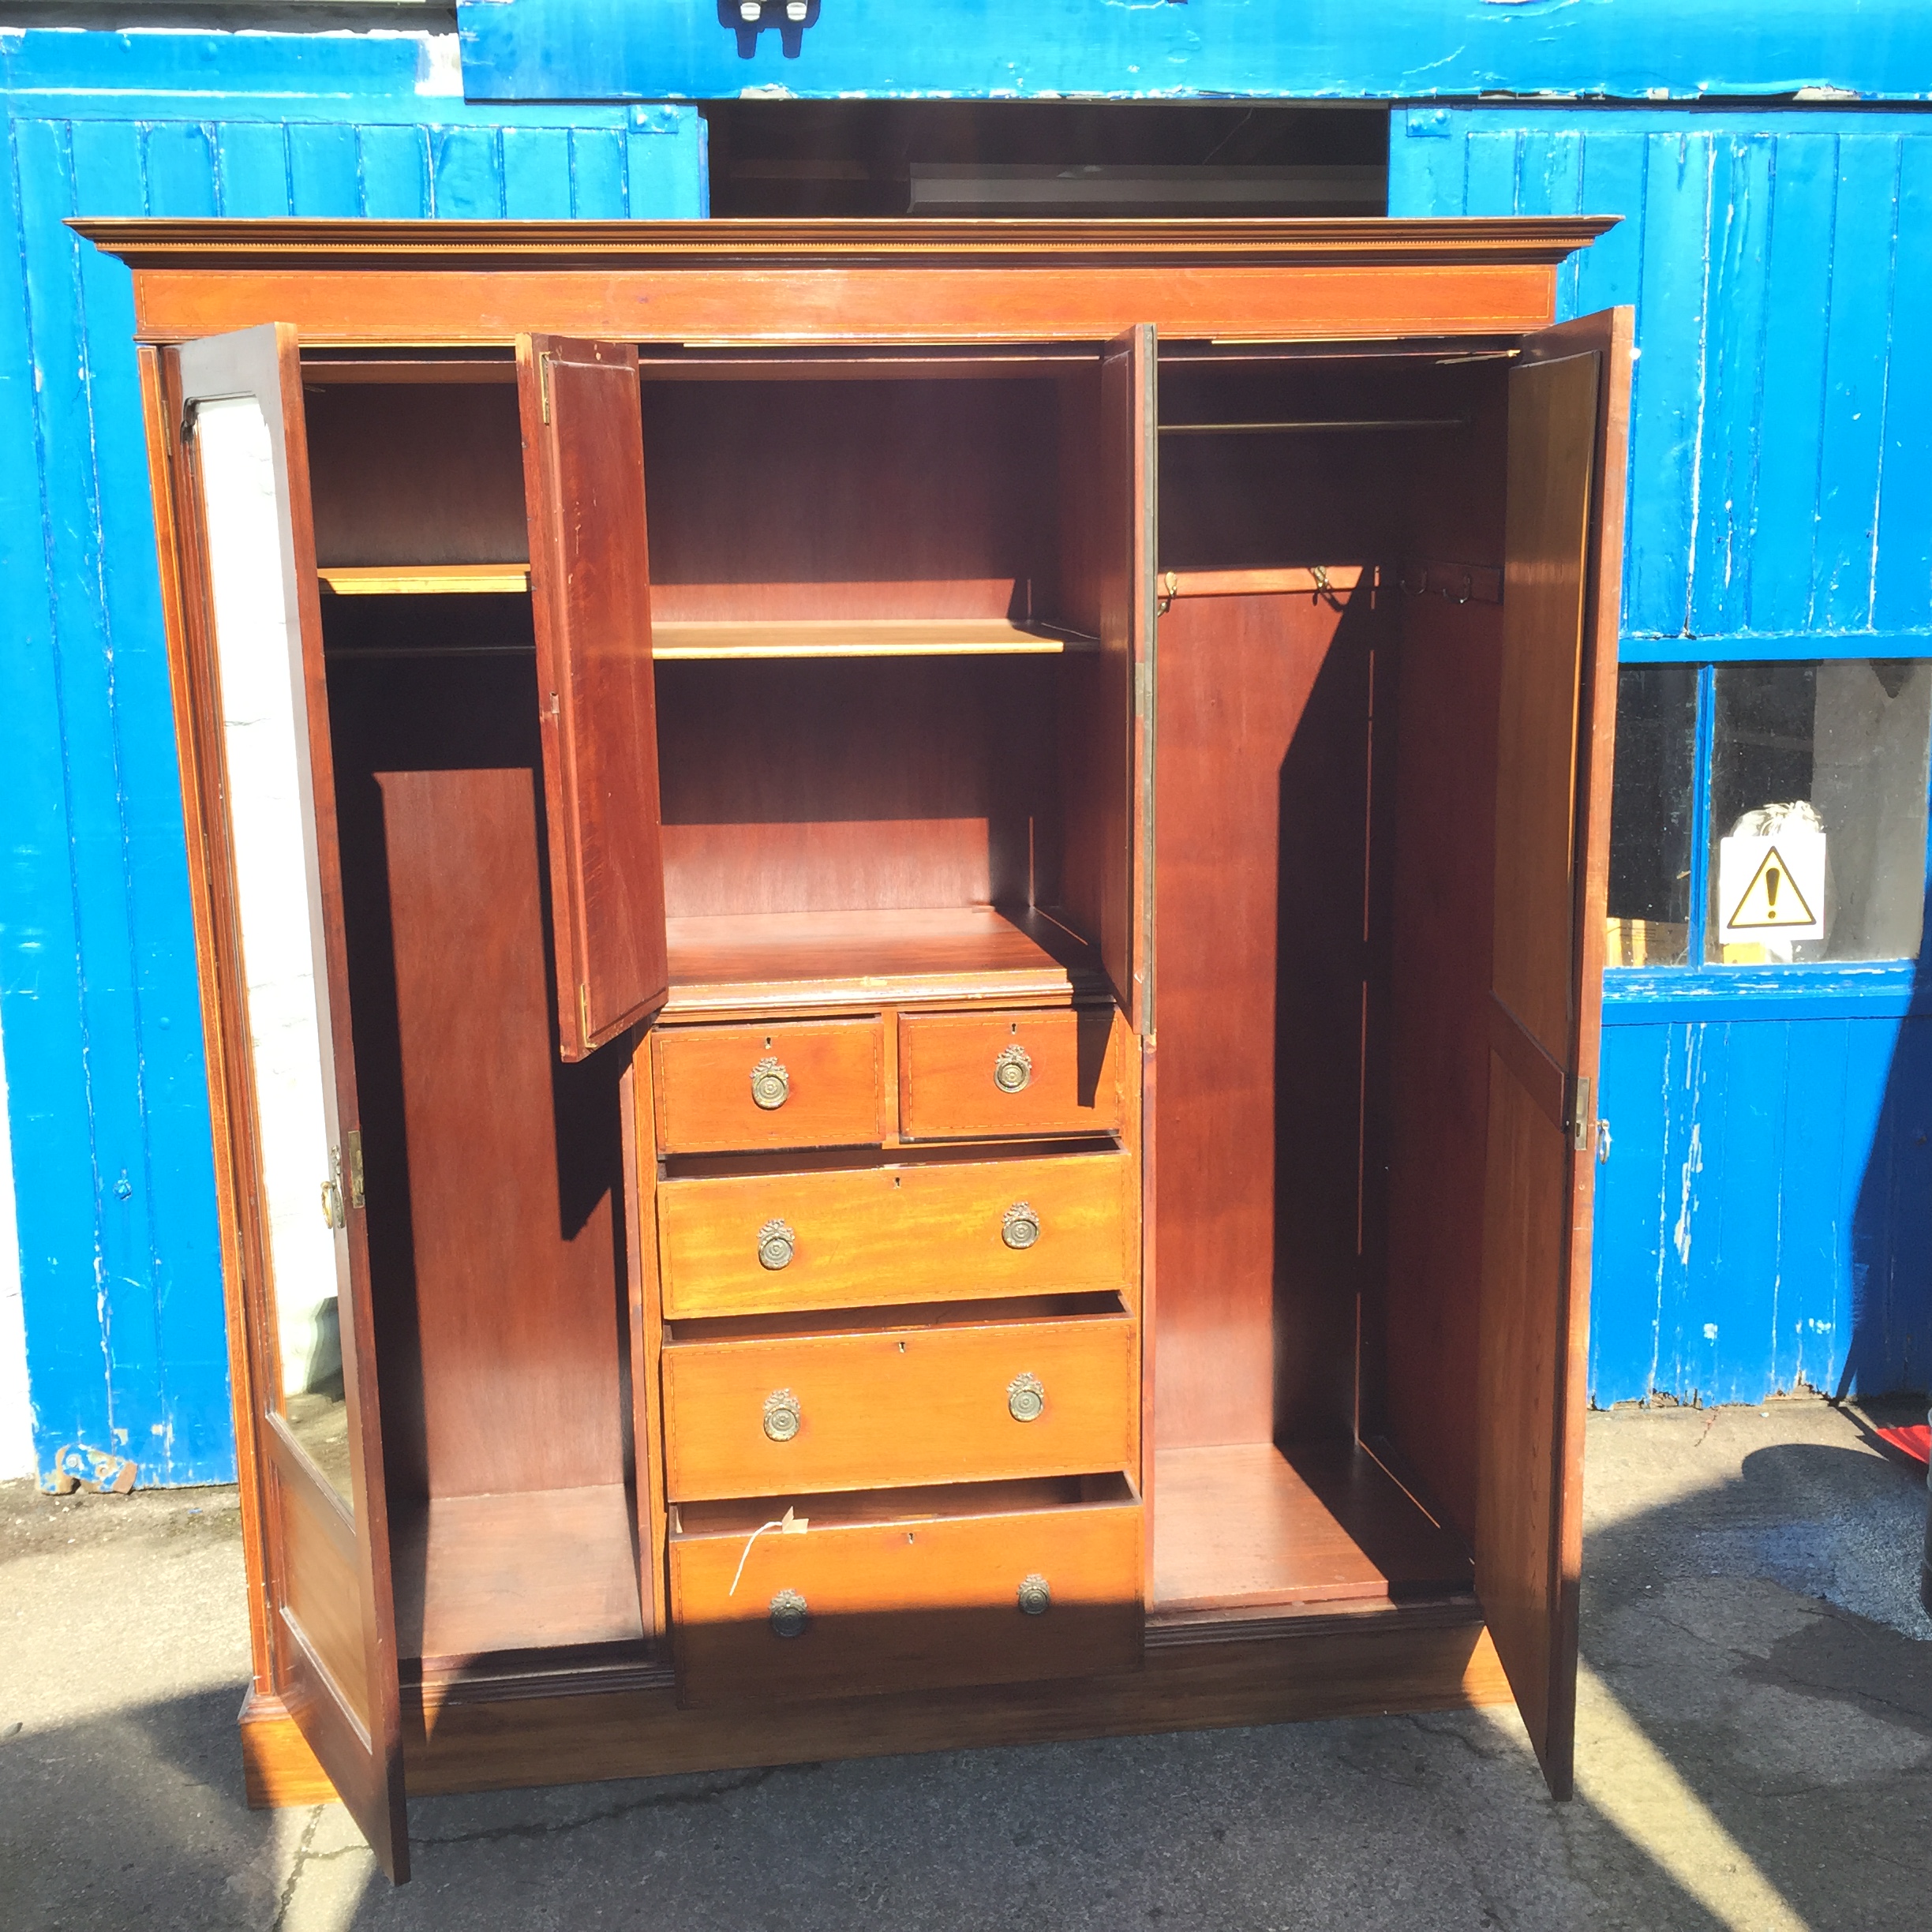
[1091,323,1159,1034]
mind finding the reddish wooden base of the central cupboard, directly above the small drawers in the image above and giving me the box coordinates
[665,906,1105,1013]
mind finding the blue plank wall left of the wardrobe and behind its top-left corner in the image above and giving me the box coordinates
[0,35,706,1482]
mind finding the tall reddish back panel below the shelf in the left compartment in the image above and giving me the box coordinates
[331,622,624,1496]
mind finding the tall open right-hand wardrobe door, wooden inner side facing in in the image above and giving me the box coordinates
[1476,309,1631,1797]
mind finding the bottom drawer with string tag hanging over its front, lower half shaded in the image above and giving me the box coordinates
[670,1476,1142,1706]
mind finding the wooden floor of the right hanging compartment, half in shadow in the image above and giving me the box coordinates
[1153,1443,1472,1613]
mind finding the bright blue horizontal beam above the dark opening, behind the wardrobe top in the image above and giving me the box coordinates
[456,0,1932,100]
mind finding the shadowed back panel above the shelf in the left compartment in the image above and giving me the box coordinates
[303,383,530,564]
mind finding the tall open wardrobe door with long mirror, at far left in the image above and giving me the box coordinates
[160,327,410,1880]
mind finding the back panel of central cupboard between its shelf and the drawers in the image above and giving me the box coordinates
[657,661,1059,918]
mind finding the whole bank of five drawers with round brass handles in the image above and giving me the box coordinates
[653,1006,1144,1704]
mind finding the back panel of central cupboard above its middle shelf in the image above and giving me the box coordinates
[643,380,1055,620]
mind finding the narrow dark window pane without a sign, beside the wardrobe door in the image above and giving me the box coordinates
[1604,665,1698,966]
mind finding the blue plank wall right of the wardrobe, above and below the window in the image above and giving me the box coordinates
[1389,107,1932,1402]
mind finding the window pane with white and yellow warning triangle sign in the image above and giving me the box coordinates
[1704,659,1932,966]
